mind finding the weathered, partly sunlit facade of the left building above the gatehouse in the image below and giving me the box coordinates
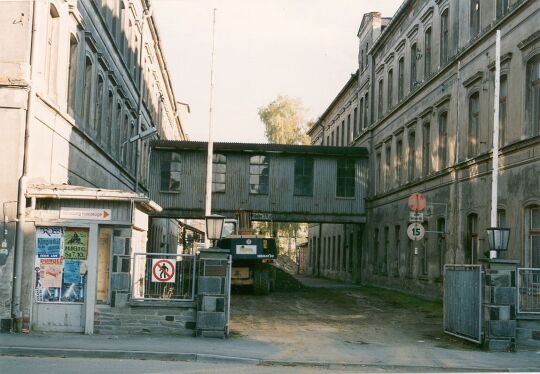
[0,0,184,328]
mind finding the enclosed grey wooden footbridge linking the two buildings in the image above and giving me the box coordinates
[149,141,368,223]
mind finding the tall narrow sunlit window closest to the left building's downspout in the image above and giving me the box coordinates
[45,4,60,100]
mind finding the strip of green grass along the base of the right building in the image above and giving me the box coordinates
[361,286,443,318]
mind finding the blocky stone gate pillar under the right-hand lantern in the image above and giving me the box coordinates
[484,259,518,352]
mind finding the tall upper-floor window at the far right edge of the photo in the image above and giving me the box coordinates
[525,55,540,136]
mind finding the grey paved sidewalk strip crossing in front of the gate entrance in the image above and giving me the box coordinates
[0,276,540,372]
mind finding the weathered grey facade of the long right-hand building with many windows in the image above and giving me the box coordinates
[308,1,540,297]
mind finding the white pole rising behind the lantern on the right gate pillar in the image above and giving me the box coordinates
[489,30,501,259]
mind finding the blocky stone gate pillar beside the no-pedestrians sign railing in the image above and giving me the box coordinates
[196,248,231,338]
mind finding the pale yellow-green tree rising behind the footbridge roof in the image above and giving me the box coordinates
[259,95,309,144]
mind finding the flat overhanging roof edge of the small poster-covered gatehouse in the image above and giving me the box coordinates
[26,184,162,213]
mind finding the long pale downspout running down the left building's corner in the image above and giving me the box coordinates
[11,1,37,332]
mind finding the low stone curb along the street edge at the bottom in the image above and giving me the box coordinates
[0,346,520,372]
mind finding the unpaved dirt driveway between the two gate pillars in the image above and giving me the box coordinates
[231,280,478,358]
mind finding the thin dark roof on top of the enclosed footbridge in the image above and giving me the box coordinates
[150,140,368,158]
